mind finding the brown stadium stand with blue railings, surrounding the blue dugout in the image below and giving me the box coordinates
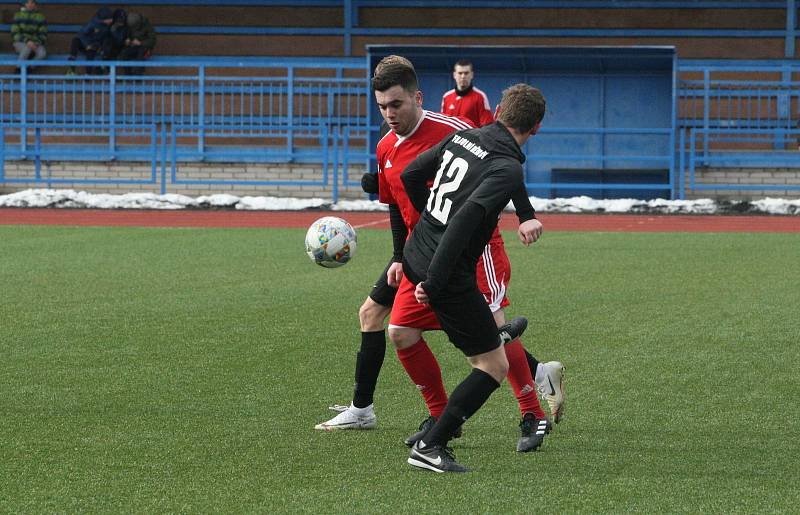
[0,0,800,198]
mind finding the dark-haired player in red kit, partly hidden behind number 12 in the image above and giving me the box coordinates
[373,58,547,452]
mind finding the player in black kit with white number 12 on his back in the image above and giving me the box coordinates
[401,84,545,472]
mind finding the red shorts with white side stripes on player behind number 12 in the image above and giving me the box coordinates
[389,240,511,330]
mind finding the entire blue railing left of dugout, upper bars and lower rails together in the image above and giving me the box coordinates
[0,58,368,202]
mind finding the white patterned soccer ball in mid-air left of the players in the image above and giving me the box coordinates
[306,216,356,268]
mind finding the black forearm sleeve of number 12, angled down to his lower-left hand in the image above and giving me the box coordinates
[422,201,486,299]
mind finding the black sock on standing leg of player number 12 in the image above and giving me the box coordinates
[422,368,500,446]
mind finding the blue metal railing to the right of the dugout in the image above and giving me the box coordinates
[678,61,800,198]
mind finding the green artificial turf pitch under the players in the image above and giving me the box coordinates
[0,226,800,513]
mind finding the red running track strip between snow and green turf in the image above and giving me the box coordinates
[0,208,800,233]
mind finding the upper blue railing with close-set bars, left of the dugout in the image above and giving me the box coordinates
[0,59,367,160]
